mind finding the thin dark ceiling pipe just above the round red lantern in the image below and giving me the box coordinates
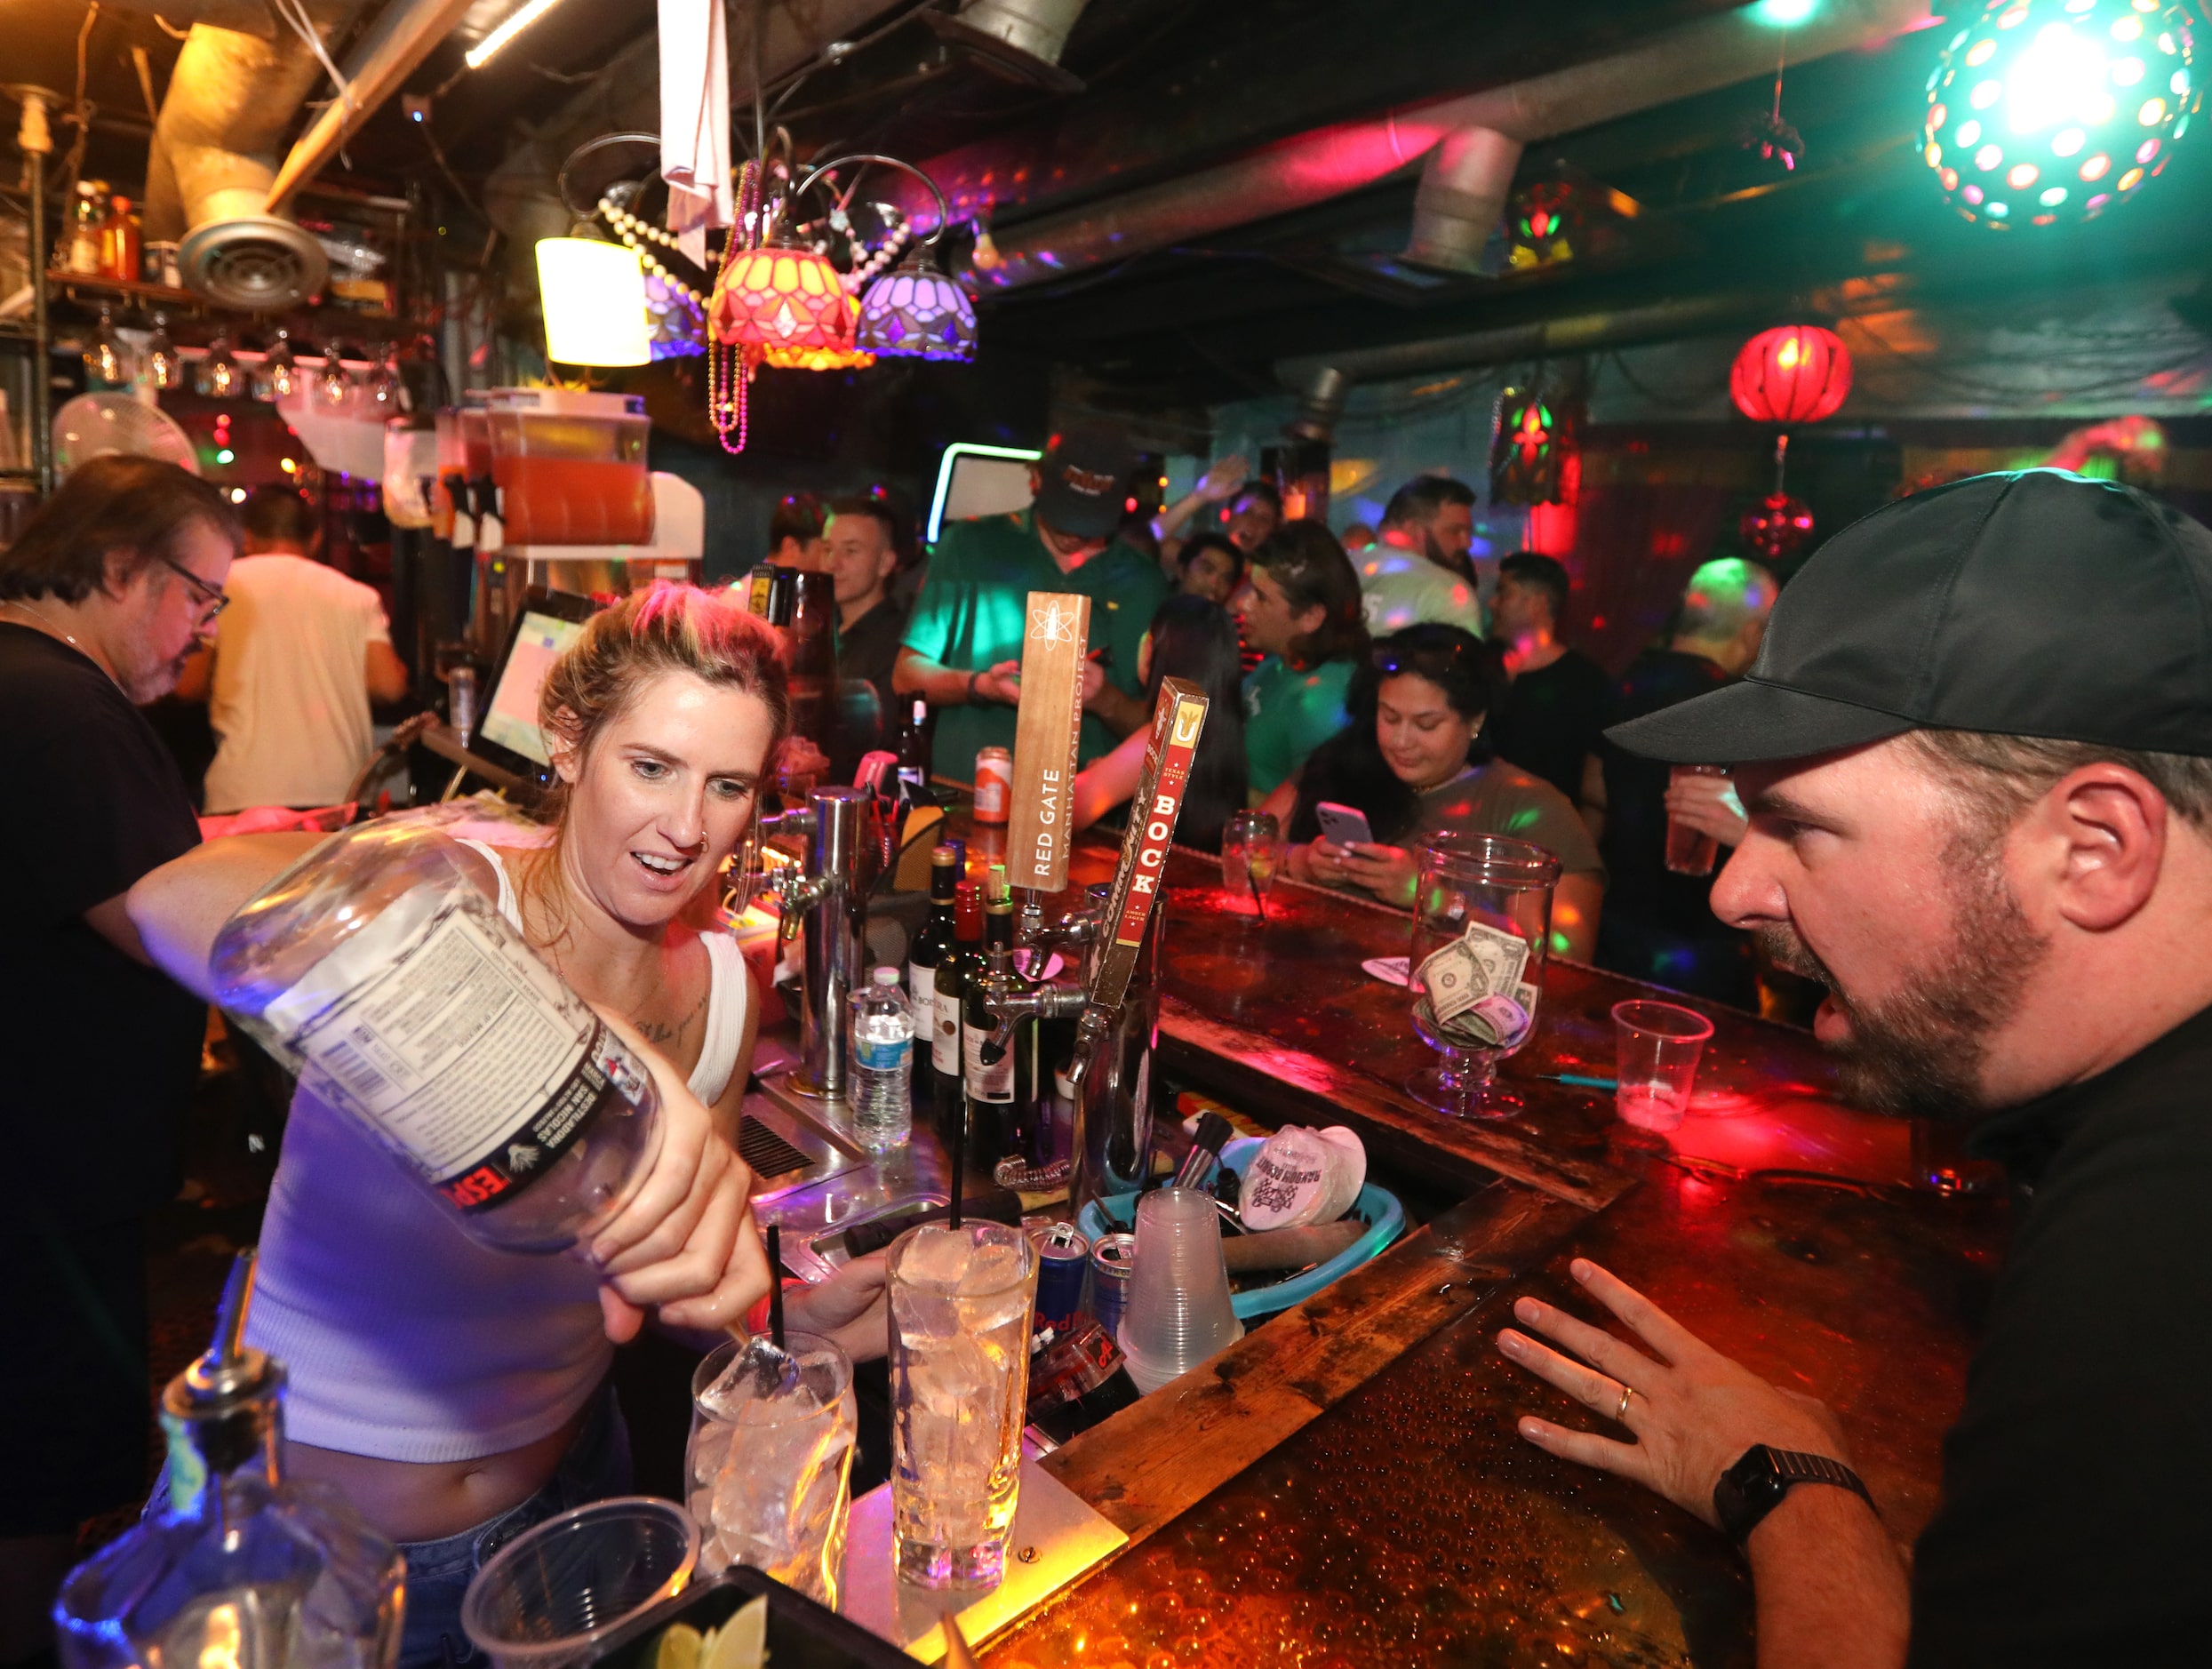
[1274,290,1790,393]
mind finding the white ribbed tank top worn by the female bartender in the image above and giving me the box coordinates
[245,840,752,1461]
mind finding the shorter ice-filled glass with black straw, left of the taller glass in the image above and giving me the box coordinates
[683,1333,860,1607]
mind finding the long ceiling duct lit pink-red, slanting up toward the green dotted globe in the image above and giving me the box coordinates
[960,0,1929,290]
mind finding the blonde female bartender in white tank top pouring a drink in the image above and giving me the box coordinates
[131,586,885,1669]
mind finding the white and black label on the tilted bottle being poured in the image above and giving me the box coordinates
[283,904,623,1211]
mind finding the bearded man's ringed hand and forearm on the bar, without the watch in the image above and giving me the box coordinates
[1497,1258,1911,1669]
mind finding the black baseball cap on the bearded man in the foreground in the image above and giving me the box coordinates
[1606,468,2212,765]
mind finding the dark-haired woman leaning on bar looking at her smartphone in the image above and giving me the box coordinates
[1276,623,1606,962]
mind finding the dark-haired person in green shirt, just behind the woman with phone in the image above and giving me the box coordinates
[1243,522,1367,804]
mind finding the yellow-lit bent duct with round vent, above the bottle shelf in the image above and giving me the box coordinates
[146,24,330,309]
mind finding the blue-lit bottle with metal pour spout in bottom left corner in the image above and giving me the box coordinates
[53,1251,407,1669]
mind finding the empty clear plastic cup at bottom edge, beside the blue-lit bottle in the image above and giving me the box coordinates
[460,1494,699,1669]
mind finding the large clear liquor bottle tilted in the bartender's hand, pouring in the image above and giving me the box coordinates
[210,809,659,1251]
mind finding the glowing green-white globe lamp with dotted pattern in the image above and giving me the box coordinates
[1920,0,2203,230]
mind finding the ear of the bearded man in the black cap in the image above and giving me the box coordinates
[2008,761,2172,933]
